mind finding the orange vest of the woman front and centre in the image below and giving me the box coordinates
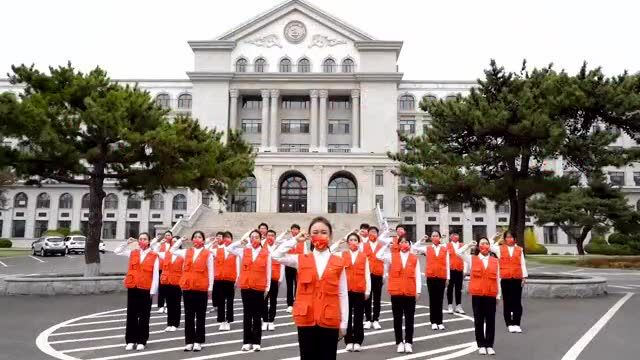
[293,254,344,329]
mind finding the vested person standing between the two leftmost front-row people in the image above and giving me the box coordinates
[151,231,184,332]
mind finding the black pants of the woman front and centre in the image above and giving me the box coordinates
[298,326,338,360]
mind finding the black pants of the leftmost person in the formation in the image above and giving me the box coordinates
[124,288,151,345]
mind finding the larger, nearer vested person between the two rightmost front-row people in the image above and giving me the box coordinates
[414,230,450,330]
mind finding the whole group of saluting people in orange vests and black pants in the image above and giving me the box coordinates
[115,217,528,360]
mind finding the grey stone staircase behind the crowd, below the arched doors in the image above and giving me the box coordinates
[174,206,378,239]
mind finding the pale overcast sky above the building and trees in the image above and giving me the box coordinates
[0,0,640,80]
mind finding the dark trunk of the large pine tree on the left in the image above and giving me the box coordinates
[84,176,106,276]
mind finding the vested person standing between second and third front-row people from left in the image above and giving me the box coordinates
[209,231,240,331]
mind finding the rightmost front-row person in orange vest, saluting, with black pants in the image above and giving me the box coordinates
[456,237,501,355]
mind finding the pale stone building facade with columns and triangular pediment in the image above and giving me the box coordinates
[0,0,640,253]
